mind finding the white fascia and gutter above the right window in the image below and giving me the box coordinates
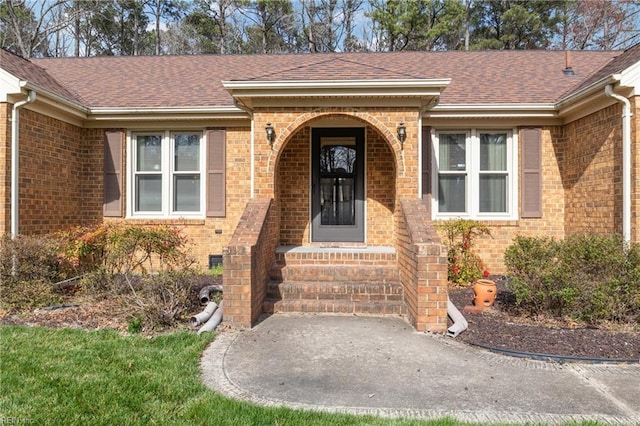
[423,104,558,118]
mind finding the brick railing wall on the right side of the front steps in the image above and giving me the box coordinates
[396,199,447,333]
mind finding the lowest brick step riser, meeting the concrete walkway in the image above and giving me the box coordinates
[263,299,407,316]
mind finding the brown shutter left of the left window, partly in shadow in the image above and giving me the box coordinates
[102,130,124,217]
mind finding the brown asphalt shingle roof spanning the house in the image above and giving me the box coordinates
[0,46,640,108]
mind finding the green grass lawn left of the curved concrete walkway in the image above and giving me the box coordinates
[0,326,459,426]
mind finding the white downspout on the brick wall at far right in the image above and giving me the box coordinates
[604,84,631,243]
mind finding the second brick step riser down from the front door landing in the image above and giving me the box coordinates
[270,265,399,283]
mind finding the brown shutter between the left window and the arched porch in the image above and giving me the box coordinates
[207,129,226,217]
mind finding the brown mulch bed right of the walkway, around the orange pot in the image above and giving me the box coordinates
[449,279,640,360]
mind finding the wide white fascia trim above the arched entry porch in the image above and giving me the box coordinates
[222,79,451,98]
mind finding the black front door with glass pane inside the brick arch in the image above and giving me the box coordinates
[311,127,364,242]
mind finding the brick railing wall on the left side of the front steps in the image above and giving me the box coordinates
[222,198,277,327]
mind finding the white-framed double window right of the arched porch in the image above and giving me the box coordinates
[432,129,518,220]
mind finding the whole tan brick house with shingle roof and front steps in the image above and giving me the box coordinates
[0,46,640,332]
